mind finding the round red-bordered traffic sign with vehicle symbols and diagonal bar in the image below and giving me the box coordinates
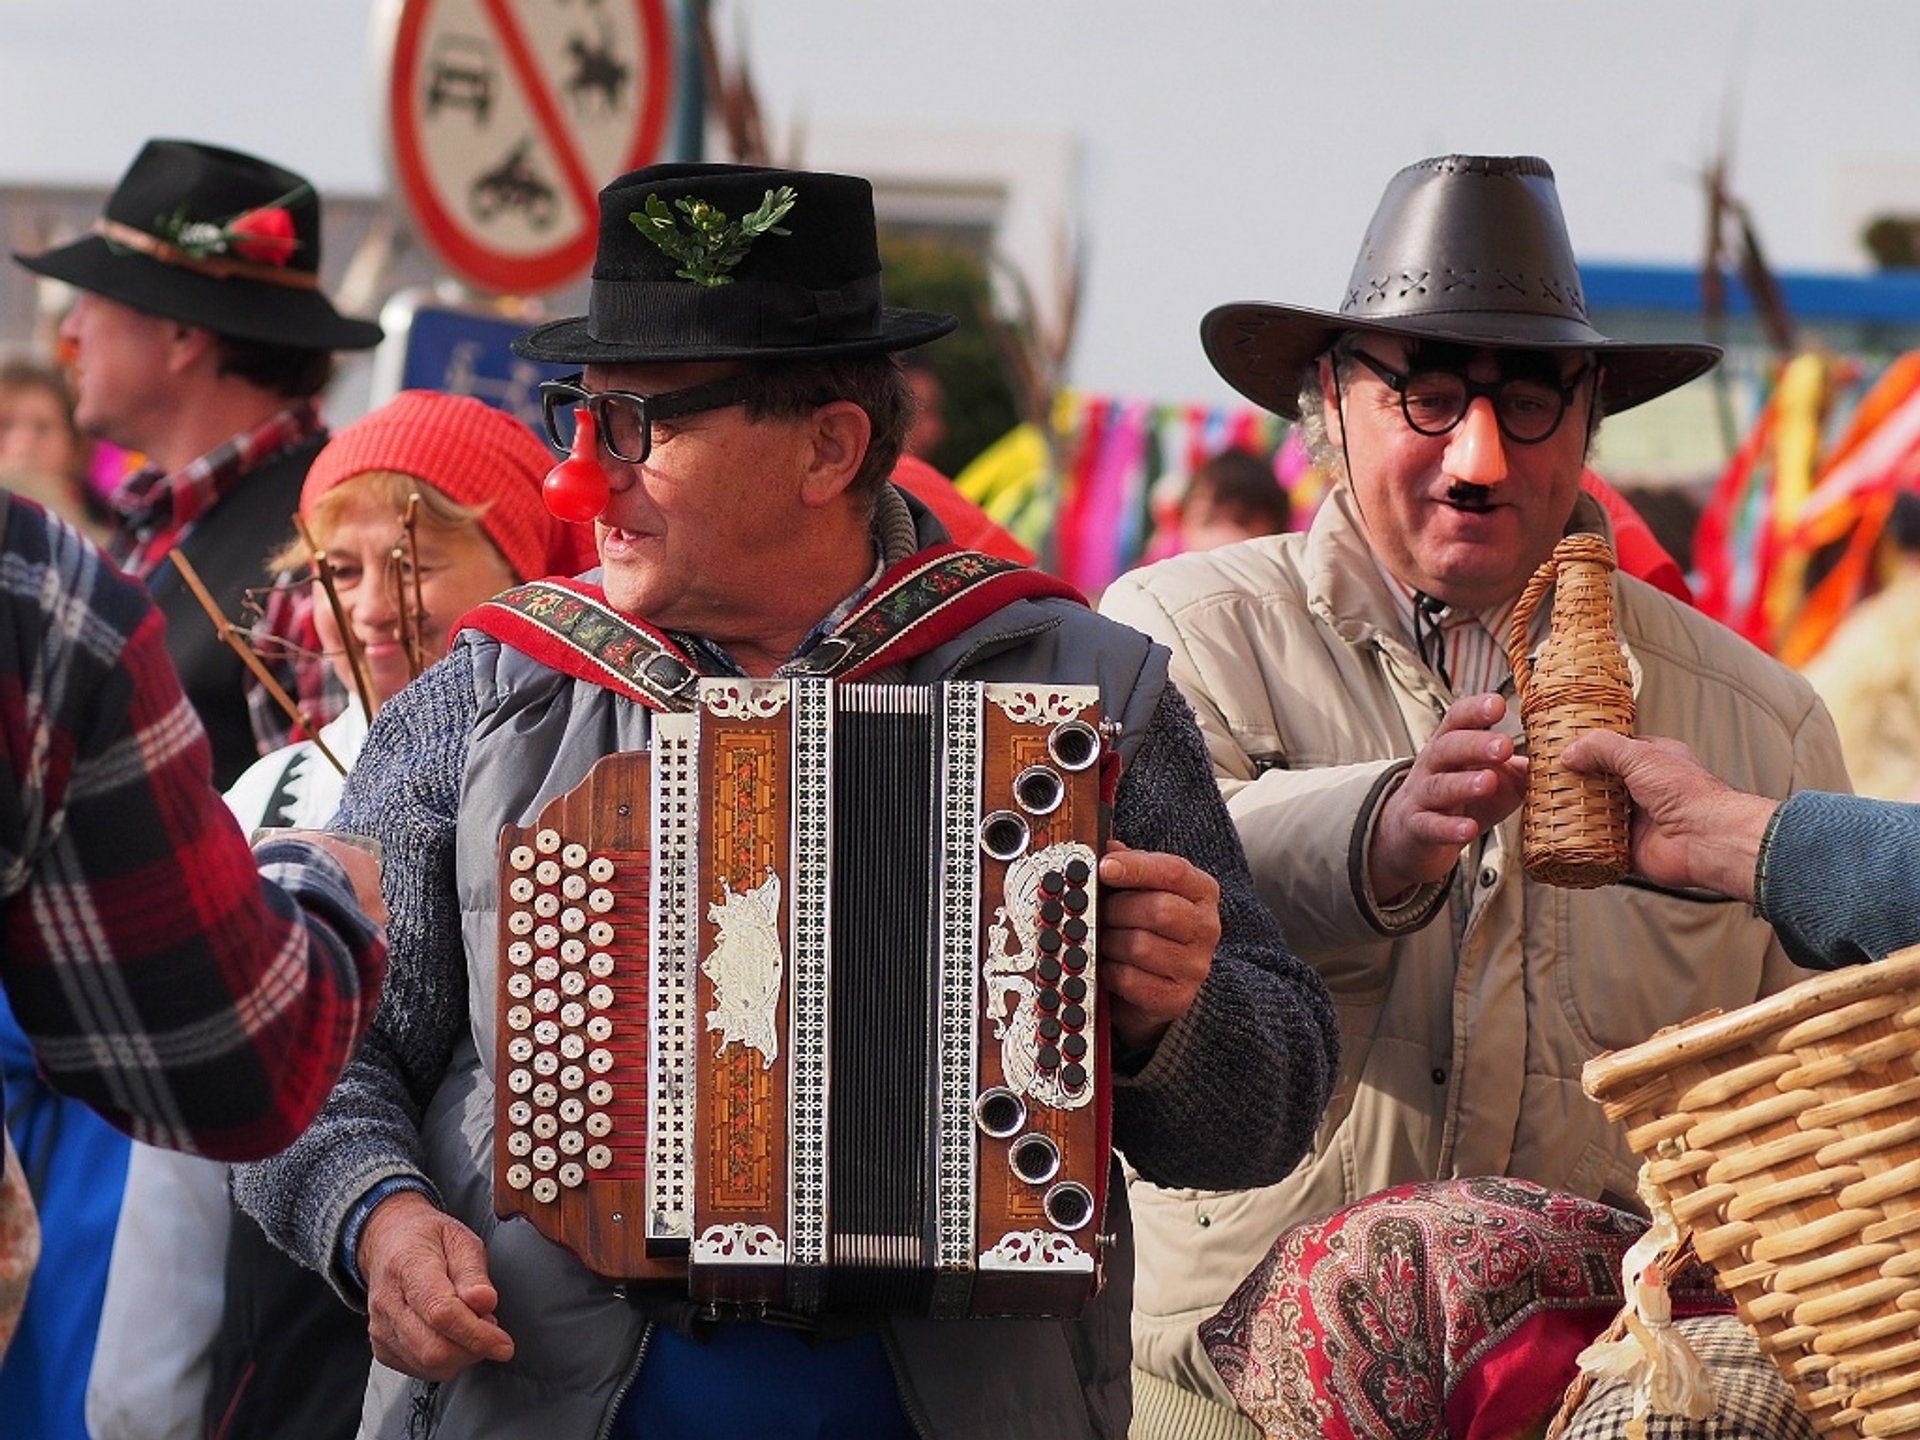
[386,0,674,294]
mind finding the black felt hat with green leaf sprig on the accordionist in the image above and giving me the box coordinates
[513,165,956,365]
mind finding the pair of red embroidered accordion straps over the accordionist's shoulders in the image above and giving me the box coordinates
[455,545,1087,710]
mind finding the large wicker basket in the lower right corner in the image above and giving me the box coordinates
[1582,947,1920,1438]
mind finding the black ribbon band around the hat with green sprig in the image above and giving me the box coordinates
[588,275,881,349]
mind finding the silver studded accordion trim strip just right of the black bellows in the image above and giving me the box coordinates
[933,684,985,1315]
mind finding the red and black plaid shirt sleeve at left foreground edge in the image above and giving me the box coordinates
[0,499,384,1158]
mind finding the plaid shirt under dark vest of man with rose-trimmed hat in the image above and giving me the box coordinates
[111,399,346,755]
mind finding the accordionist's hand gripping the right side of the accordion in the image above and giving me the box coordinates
[1100,841,1219,1050]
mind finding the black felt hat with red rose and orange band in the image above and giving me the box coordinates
[13,140,380,349]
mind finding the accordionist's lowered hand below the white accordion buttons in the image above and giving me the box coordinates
[357,1190,513,1380]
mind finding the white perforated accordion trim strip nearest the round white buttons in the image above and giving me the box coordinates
[647,714,699,1240]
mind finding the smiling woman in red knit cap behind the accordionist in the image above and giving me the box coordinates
[86,390,595,1440]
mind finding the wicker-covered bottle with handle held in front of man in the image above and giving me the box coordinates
[1507,536,1634,889]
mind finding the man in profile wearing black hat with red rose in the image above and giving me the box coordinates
[13,140,380,787]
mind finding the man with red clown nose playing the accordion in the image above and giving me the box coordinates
[236,165,1334,1440]
